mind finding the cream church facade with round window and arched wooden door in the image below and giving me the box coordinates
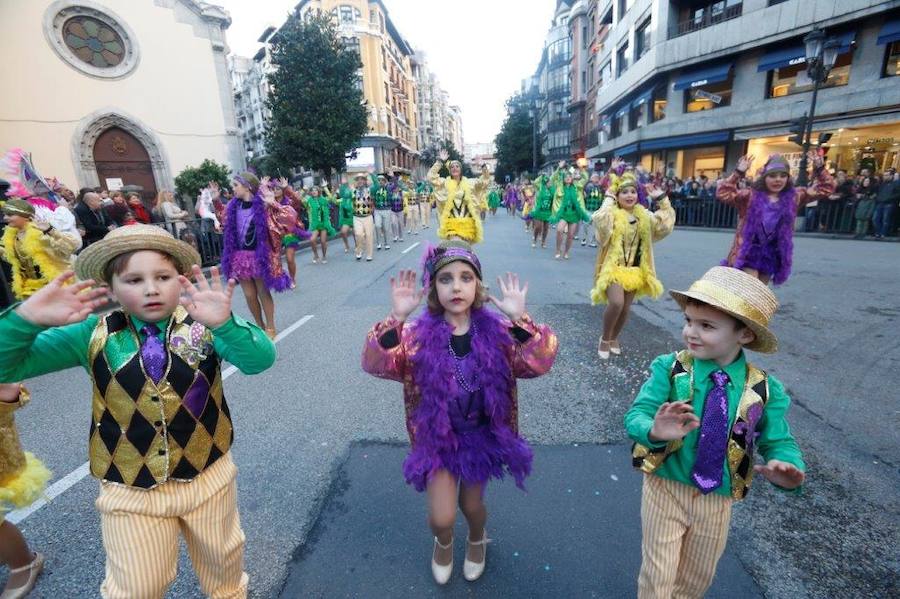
[0,0,242,202]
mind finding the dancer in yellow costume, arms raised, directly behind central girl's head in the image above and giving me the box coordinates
[428,154,491,243]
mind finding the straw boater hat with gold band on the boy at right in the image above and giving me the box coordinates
[669,266,778,354]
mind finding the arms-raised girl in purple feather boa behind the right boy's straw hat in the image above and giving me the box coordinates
[716,150,835,285]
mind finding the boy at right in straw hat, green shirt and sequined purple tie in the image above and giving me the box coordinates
[625,266,805,599]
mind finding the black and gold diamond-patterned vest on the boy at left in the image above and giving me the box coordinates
[88,306,234,489]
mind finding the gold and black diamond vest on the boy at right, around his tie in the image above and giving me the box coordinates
[631,350,769,499]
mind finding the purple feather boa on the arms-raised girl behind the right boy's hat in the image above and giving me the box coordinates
[723,187,797,285]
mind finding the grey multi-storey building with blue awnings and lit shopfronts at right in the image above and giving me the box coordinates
[587,0,900,177]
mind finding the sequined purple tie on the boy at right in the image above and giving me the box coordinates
[691,370,729,494]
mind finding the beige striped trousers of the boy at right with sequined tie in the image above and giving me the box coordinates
[638,474,732,599]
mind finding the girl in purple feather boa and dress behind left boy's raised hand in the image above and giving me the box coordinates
[222,173,297,339]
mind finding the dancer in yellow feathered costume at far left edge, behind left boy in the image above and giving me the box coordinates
[0,199,77,300]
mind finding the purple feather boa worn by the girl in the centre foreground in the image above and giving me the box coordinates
[403,308,534,491]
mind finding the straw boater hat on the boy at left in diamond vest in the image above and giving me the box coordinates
[75,225,200,283]
